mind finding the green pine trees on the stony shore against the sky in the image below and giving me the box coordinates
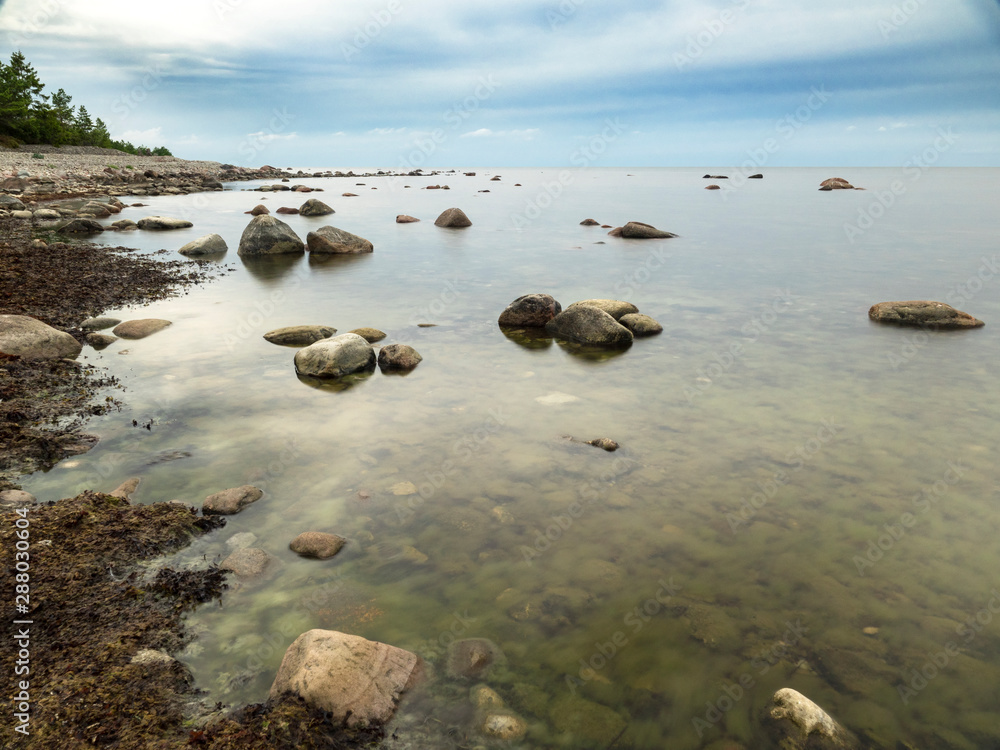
[0,52,173,156]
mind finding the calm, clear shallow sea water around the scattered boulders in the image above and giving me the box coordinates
[24,169,1000,748]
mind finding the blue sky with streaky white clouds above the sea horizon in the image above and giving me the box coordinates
[0,0,1000,170]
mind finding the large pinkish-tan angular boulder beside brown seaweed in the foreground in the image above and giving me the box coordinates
[270,629,422,727]
